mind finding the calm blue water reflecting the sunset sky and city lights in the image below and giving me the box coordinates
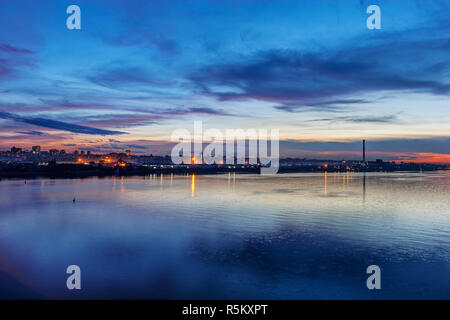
[0,172,450,299]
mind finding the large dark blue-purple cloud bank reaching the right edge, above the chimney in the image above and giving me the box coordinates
[191,35,450,112]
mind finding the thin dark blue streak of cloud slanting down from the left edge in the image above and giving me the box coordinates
[0,112,125,135]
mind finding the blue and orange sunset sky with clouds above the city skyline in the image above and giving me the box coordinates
[0,0,450,163]
